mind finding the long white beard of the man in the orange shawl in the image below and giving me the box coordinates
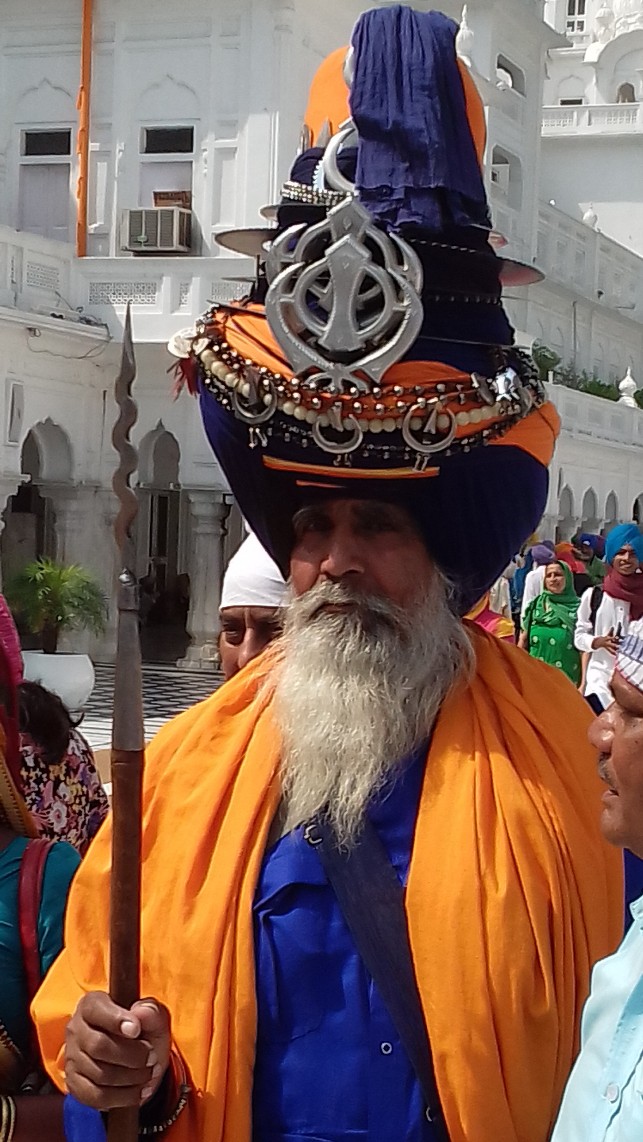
[271,571,474,845]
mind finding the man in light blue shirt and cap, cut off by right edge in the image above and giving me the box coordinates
[552,634,643,1142]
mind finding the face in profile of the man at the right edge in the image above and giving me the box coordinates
[589,674,643,858]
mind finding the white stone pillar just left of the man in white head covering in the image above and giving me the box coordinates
[177,489,230,670]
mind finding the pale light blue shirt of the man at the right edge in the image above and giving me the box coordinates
[552,896,643,1142]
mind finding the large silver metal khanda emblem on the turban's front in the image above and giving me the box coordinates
[265,199,423,395]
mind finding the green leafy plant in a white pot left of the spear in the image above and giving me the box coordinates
[5,558,107,710]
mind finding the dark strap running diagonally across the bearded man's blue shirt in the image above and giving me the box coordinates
[304,820,449,1142]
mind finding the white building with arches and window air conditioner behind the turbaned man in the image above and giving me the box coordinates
[0,0,643,667]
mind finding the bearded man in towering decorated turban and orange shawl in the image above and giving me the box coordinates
[35,7,622,1142]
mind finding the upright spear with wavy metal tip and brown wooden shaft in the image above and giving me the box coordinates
[107,305,145,1142]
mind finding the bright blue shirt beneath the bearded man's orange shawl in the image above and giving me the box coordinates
[254,746,435,1142]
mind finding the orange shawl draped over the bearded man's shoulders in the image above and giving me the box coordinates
[34,628,622,1142]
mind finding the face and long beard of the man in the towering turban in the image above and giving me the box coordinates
[268,500,473,844]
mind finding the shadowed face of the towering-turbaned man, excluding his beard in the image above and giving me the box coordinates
[290,499,433,606]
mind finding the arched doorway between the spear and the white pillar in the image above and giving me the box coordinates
[137,421,190,662]
